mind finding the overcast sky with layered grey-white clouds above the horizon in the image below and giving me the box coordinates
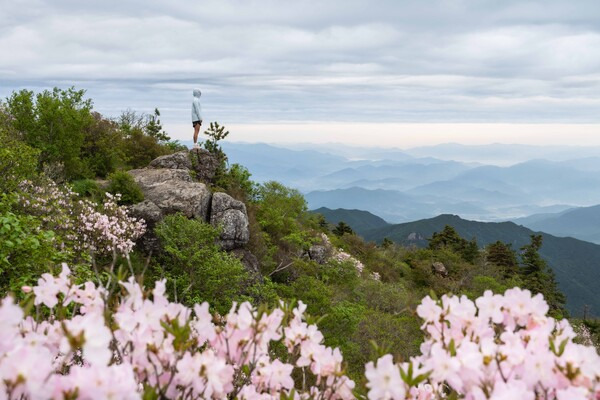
[0,0,600,145]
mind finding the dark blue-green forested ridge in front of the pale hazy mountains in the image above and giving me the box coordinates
[315,209,600,316]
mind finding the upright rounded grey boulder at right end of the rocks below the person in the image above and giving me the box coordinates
[210,193,250,250]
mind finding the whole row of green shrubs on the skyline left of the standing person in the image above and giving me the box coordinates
[0,88,184,180]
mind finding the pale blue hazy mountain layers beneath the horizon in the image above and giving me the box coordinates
[224,142,600,231]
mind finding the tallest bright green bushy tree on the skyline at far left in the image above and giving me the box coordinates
[7,88,93,178]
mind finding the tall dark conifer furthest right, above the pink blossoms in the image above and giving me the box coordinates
[521,235,567,318]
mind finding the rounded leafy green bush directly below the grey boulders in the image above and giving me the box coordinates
[151,214,248,314]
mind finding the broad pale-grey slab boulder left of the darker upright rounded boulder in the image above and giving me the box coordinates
[129,168,211,221]
